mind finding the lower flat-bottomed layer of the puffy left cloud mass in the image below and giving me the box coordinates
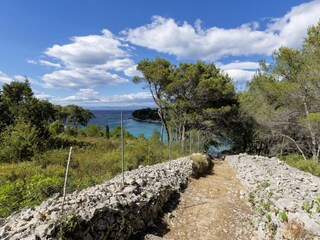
[43,68,128,89]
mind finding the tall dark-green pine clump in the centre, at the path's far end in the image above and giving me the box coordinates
[133,58,245,147]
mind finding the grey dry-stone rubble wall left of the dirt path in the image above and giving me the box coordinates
[0,158,196,240]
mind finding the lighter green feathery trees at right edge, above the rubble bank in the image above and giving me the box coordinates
[240,22,320,161]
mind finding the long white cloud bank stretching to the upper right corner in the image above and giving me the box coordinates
[122,0,320,61]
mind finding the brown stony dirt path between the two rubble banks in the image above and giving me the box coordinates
[163,161,252,240]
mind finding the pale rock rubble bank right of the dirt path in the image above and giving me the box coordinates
[226,154,320,239]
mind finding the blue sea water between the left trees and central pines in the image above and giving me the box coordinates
[89,110,161,138]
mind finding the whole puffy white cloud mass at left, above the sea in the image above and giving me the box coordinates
[41,29,135,89]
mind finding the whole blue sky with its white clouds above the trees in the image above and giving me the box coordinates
[0,0,320,109]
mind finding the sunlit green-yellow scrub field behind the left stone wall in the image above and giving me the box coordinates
[0,135,188,218]
